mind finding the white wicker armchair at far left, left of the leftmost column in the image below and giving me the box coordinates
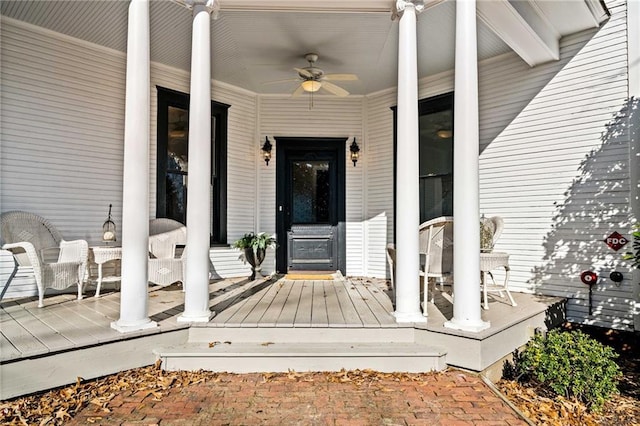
[0,211,89,308]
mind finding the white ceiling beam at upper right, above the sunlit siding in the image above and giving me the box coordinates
[477,0,560,66]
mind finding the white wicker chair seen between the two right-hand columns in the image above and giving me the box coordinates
[419,216,453,316]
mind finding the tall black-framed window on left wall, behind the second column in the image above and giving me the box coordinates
[156,87,229,244]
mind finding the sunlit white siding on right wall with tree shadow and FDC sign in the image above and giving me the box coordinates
[480,1,633,327]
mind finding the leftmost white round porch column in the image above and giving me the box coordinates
[111,0,157,333]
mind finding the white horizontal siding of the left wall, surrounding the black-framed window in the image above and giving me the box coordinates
[0,18,257,290]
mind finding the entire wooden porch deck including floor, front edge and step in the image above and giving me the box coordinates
[0,277,564,399]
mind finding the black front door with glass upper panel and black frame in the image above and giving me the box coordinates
[276,138,345,273]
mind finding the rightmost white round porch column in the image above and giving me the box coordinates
[444,0,489,332]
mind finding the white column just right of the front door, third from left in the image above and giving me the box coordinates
[394,0,426,322]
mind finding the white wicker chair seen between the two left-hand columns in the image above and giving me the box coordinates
[149,219,187,290]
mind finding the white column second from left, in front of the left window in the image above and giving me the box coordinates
[178,1,213,322]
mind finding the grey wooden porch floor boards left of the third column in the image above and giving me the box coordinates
[0,278,398,363]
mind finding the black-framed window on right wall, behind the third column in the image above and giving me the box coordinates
[392,92,453,223]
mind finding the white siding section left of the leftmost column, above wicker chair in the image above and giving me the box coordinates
[0,18,125,244]
